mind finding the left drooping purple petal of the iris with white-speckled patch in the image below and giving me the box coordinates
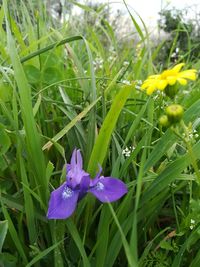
[47,183,79,219]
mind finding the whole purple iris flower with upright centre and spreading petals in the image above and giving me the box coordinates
[47,149,127,219]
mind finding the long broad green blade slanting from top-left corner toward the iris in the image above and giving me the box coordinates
[3,0,48,203]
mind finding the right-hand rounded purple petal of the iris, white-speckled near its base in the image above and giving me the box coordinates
[88,176,128,202]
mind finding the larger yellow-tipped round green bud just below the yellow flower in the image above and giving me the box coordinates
[165,104,184,123]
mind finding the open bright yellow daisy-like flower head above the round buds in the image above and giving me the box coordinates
[141,63,197,95]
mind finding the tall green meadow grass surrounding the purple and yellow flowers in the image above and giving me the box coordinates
[0,0,200,267]
